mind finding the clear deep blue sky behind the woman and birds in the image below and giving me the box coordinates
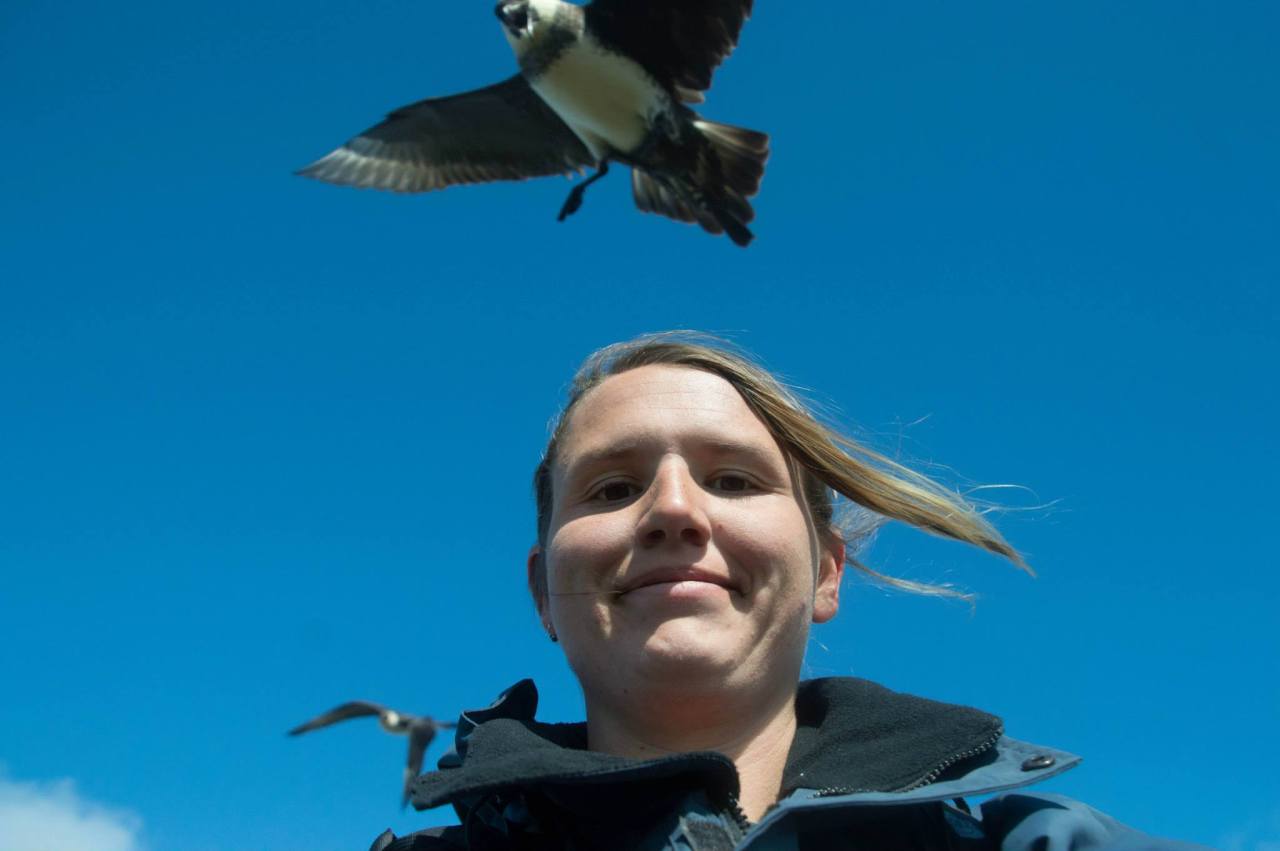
[0,0,1280,851]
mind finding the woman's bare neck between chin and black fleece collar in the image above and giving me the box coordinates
[586,687,796,822]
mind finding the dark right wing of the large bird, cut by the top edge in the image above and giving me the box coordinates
[585,0,753,94]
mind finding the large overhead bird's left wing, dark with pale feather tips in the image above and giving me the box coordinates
[298,74,595,192]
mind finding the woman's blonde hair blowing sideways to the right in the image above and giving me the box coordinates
[534,331,1032,599]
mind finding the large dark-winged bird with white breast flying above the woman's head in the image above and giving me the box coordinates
[298,0,769,246]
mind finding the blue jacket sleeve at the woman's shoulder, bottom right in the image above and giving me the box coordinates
[982,793,1211,851]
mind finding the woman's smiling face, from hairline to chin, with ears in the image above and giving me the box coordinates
[530,366,844,701]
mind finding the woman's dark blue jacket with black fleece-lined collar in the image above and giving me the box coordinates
[371,677,1201,851]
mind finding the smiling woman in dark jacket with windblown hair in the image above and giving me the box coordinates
[374,334,1189,851]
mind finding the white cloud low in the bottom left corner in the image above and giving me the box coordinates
[0,774,142,851]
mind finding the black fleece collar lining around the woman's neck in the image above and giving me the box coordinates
[413,677,1002,809]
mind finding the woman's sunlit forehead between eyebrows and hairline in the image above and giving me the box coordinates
[559,365,782,466]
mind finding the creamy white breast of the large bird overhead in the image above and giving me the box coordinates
[530,37,667,157]
